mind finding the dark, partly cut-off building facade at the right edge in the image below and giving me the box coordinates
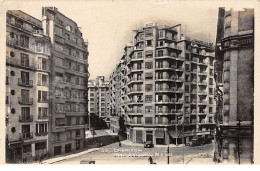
[215,8,254,164]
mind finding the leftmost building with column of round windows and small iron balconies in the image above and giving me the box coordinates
[6,10,51,163]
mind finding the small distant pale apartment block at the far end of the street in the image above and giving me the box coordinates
[88,76,110,127]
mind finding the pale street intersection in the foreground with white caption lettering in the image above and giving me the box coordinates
[54,142,214,165]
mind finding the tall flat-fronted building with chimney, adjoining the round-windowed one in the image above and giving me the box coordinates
[42,7,89,156]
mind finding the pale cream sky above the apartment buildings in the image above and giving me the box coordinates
[3,0,218,79]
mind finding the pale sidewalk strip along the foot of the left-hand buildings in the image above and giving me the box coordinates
[42,148,99,164]
